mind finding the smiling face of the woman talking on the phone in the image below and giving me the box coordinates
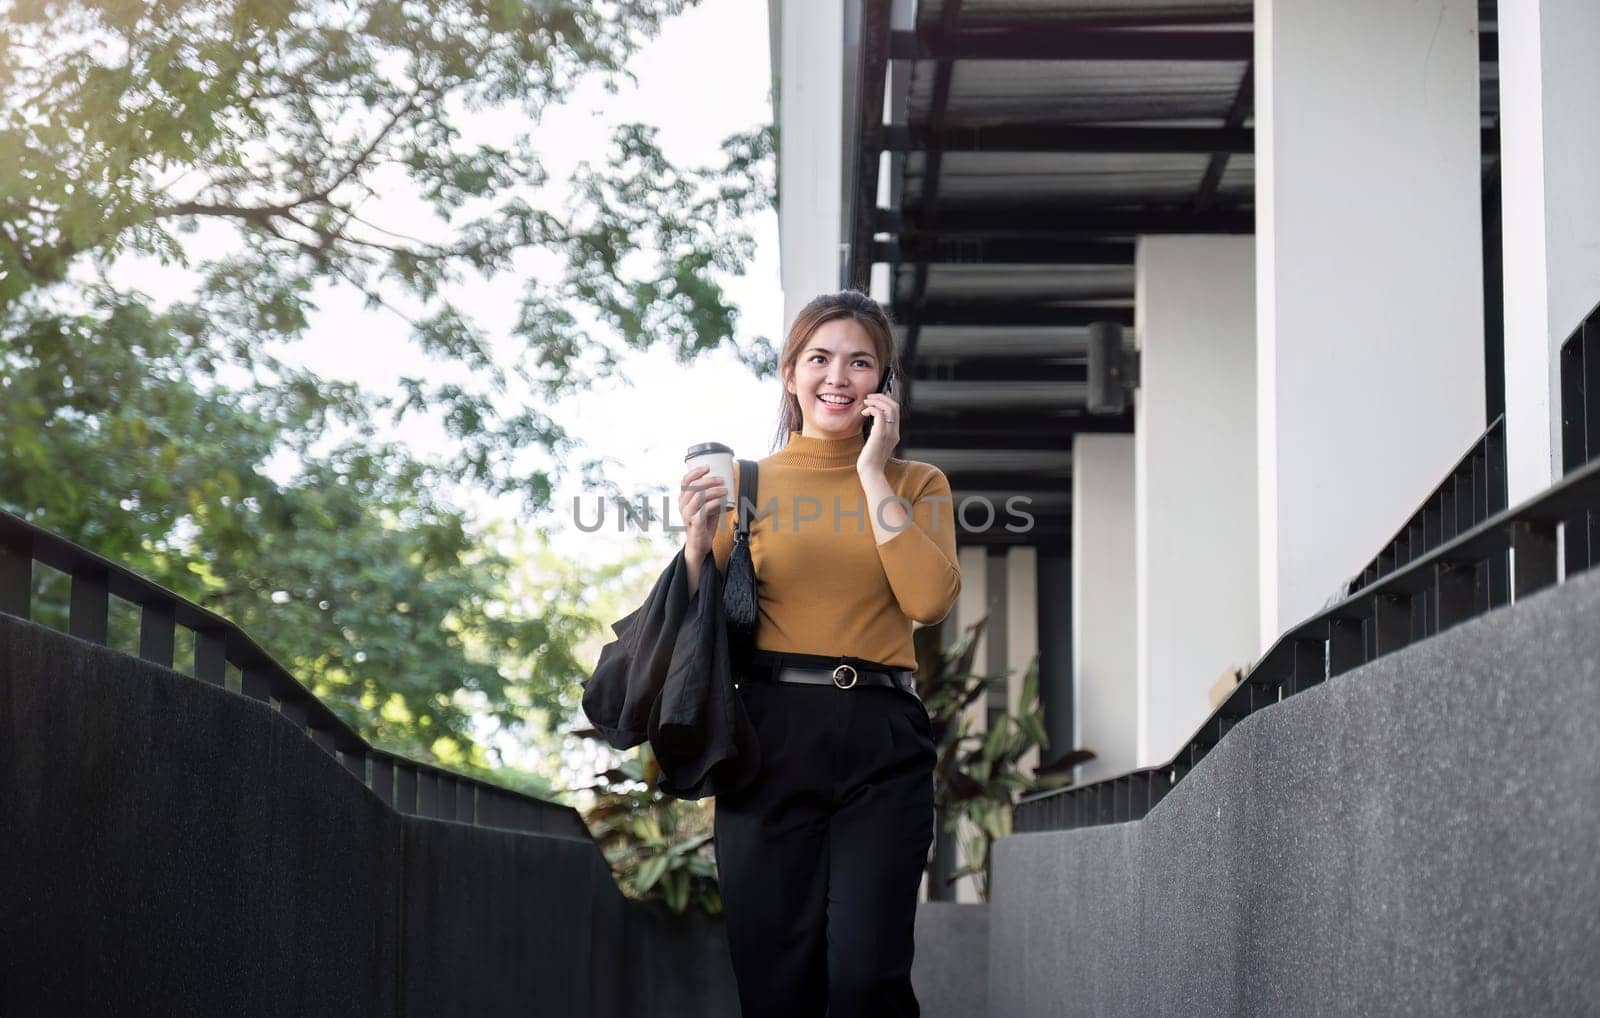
[784,319,882,439]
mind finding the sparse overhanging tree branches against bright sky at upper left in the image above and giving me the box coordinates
[0,0,773,512]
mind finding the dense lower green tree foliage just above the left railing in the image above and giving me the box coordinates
[0,295,595,765]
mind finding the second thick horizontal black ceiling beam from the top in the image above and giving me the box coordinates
[883,123,1254,155]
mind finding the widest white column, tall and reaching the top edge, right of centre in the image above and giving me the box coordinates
[1256,0,1485,642]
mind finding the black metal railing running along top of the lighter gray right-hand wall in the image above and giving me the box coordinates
[1013,458,1600,831]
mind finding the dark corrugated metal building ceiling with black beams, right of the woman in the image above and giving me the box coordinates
[848,0,1498,544]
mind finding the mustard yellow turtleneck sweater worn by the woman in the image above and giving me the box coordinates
[712,431,962,667]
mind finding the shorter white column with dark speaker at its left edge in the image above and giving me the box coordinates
[1133,237,1261,767]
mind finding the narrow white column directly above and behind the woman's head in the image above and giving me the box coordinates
[776,0,845,328]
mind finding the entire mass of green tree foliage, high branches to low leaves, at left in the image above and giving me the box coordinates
[0,0,773,768]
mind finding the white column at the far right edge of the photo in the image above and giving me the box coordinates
[1499,0,1600,506]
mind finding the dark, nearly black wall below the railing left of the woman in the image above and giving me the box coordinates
[0,615,738,1018]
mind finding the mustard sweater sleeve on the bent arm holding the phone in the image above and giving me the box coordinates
[878,467,962,626]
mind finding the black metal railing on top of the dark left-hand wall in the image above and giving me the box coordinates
[0,511,590,840]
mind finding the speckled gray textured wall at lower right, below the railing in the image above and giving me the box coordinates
[989,575,1600,1018]
